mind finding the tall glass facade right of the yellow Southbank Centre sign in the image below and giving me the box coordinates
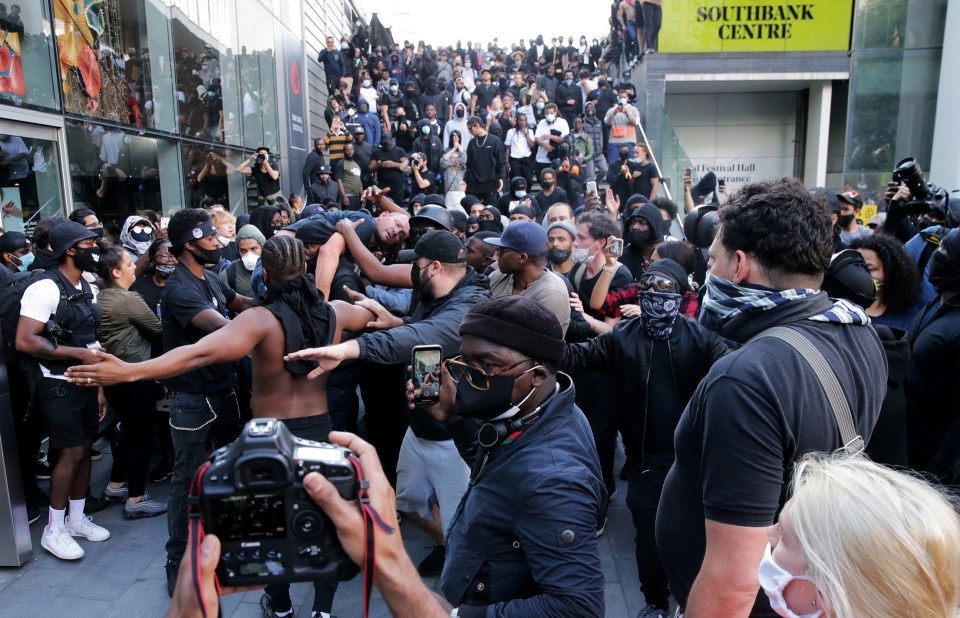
[844,0,947,191]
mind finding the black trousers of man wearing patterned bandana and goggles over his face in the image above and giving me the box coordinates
[627,462,670,610]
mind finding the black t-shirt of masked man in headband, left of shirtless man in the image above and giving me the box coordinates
[160,264,237,393]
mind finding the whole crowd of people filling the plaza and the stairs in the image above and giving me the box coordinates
[0,19,960,618]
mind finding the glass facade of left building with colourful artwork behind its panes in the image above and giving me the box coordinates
[0,0,312,224]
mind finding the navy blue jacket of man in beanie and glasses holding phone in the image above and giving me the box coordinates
[440,374,607,618]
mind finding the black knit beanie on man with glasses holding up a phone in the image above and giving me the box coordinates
[460,296,566,363]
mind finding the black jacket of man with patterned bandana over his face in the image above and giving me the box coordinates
[560,316,736,469]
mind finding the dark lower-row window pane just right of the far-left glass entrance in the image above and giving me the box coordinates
[66,121,183,239]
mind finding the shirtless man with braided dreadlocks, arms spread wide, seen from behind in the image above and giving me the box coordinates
[68,235,374,617]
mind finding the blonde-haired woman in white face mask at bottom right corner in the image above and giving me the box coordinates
[758,455,960,618]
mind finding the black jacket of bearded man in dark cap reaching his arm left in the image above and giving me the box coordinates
[356,268,490,440]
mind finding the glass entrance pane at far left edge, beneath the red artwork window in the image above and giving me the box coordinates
[0,121,63,236]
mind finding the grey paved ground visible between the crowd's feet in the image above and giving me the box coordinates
[0,443,642,618]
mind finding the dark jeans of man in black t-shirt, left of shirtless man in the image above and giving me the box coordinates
[166,390,240,564]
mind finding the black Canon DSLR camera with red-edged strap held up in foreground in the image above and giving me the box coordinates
[200,418,359,586]
